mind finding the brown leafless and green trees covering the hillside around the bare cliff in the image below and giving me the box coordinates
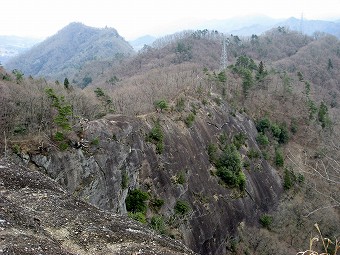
[0,27,340,254]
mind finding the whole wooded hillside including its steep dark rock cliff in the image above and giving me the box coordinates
[0,27,340,254]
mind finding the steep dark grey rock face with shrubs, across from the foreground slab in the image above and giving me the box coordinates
[25,104,282,254]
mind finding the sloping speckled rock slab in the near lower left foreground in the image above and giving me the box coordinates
[0,159,194,255]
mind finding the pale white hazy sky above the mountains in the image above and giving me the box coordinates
[0,0,340,40]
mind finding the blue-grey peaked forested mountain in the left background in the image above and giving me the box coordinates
[6,23,133,86]
